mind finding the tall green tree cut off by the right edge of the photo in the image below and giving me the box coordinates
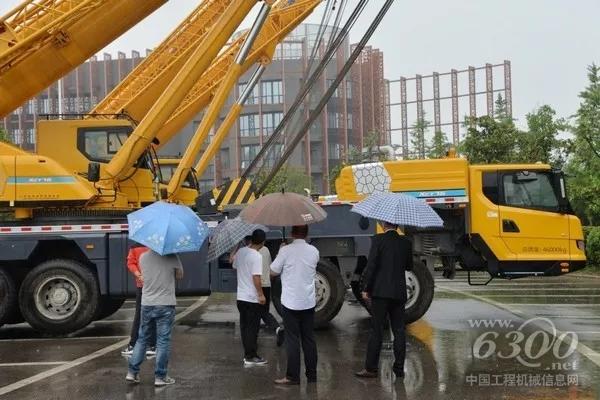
[566,64,600,225]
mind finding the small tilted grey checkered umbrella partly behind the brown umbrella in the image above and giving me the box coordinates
[208,217,268,261]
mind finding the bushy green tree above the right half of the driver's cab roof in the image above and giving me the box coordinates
[518,105,568,167]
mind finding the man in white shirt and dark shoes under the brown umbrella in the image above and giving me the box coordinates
[271,225,319,385]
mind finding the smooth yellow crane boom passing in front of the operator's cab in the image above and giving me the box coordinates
[100,0,262,189]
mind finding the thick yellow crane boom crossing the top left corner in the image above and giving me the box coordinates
[0,0,167,117]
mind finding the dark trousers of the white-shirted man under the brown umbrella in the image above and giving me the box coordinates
[281,305,317,381]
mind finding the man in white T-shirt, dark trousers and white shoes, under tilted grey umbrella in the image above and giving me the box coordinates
[233,229,267,365]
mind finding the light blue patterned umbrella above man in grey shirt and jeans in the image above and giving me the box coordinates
[127,201,208,255]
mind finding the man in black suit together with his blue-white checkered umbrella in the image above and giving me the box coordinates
[352,193,444,378]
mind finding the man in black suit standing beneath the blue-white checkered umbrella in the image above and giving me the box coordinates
[356,222,413,378]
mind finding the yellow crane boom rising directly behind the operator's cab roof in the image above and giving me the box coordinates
[90,0,233,121]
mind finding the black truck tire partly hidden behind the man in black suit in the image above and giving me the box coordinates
[351,262,434,324]
